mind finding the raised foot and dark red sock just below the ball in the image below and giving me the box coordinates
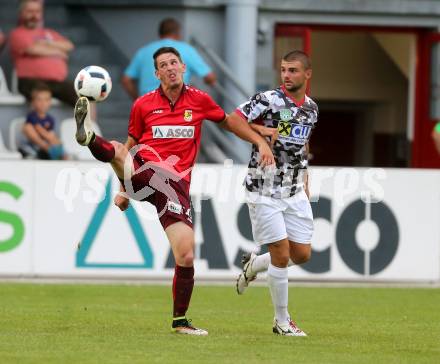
[74,97,115,162]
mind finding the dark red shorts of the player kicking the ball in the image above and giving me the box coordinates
[120,156,193,229]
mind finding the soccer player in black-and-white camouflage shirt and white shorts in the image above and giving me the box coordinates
[232,51,318,336]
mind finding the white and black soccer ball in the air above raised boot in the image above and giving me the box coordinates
[74,66,112,102]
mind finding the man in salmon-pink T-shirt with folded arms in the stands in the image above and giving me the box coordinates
[9,0,77,106]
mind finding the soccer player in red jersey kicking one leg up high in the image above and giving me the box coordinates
[75,47,274,335]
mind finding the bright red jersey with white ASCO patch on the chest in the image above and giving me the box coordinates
[128,85,226,181]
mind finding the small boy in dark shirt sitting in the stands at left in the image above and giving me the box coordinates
[19,83,64,160]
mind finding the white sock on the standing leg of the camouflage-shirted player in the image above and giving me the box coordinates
[267,264,289,324]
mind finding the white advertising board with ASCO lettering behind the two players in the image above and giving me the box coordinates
[0,161,440,282]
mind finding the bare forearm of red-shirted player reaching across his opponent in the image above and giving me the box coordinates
[220,112,275,167]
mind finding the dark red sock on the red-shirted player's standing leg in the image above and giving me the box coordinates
[173,265,194,317]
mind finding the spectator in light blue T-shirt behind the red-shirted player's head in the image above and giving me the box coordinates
[121,18,216,100]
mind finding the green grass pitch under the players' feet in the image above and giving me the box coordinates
[0,283,440,364]
